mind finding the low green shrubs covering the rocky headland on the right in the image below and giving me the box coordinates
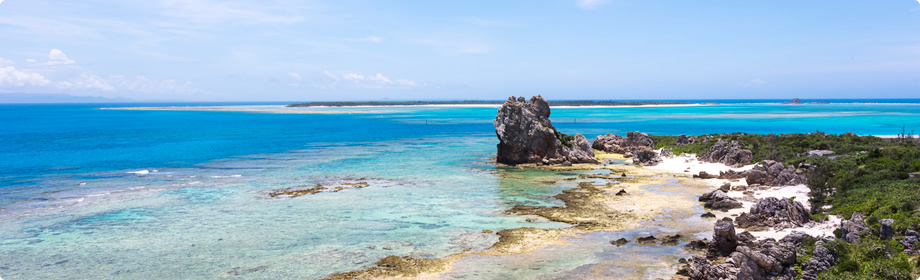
[652,132,920,280]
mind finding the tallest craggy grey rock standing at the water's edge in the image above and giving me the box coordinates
[495,95,598,164]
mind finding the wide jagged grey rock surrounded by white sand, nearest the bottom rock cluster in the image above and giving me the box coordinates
[735,197,811,230]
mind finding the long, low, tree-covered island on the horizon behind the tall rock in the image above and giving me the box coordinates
[287,100,697,107]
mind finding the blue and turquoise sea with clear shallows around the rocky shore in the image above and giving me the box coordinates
[0,99,920,279]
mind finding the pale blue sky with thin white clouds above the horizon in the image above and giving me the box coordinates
[0,0,920,101]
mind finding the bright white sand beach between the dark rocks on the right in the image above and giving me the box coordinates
[646,155,841,240]
